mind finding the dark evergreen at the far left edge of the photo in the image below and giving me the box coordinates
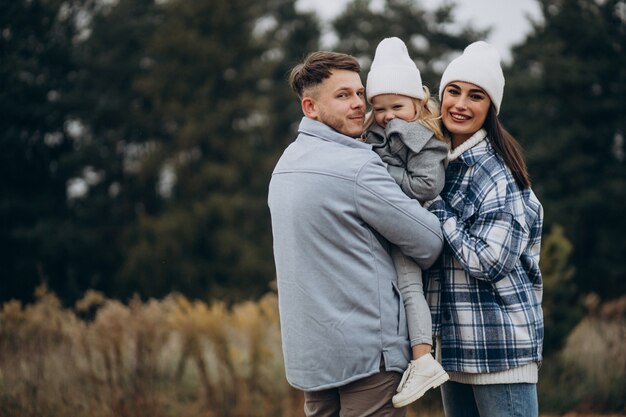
[0,0,82,301]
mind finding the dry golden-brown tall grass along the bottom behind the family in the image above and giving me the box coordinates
[0,288,626,417]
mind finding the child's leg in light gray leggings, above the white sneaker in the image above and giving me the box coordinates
[391,246,433,359]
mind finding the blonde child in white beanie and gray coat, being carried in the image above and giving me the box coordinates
[364,37,448,407]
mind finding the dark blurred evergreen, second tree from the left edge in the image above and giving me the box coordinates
[65,0,163,298]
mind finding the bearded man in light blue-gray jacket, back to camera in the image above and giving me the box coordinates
[268,52,443,417]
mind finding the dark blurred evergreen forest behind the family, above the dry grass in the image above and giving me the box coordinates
[0,0,626,409]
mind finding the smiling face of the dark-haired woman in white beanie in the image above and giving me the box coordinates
[441,81,491,147]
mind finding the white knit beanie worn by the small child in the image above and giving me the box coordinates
[365,37,424,102]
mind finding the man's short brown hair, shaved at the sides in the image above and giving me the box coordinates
[289,51,361,98]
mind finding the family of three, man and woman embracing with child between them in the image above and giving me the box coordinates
[268,38,543,417]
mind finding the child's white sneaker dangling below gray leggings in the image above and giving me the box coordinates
[391,354,449,408]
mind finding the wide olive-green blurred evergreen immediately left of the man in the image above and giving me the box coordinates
[120,0,318,299]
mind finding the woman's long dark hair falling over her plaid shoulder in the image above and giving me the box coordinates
[483,103,530,189]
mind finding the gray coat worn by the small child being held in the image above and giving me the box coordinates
[365,119,448,204]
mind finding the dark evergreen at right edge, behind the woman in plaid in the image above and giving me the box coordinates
[502,0,626,298]
